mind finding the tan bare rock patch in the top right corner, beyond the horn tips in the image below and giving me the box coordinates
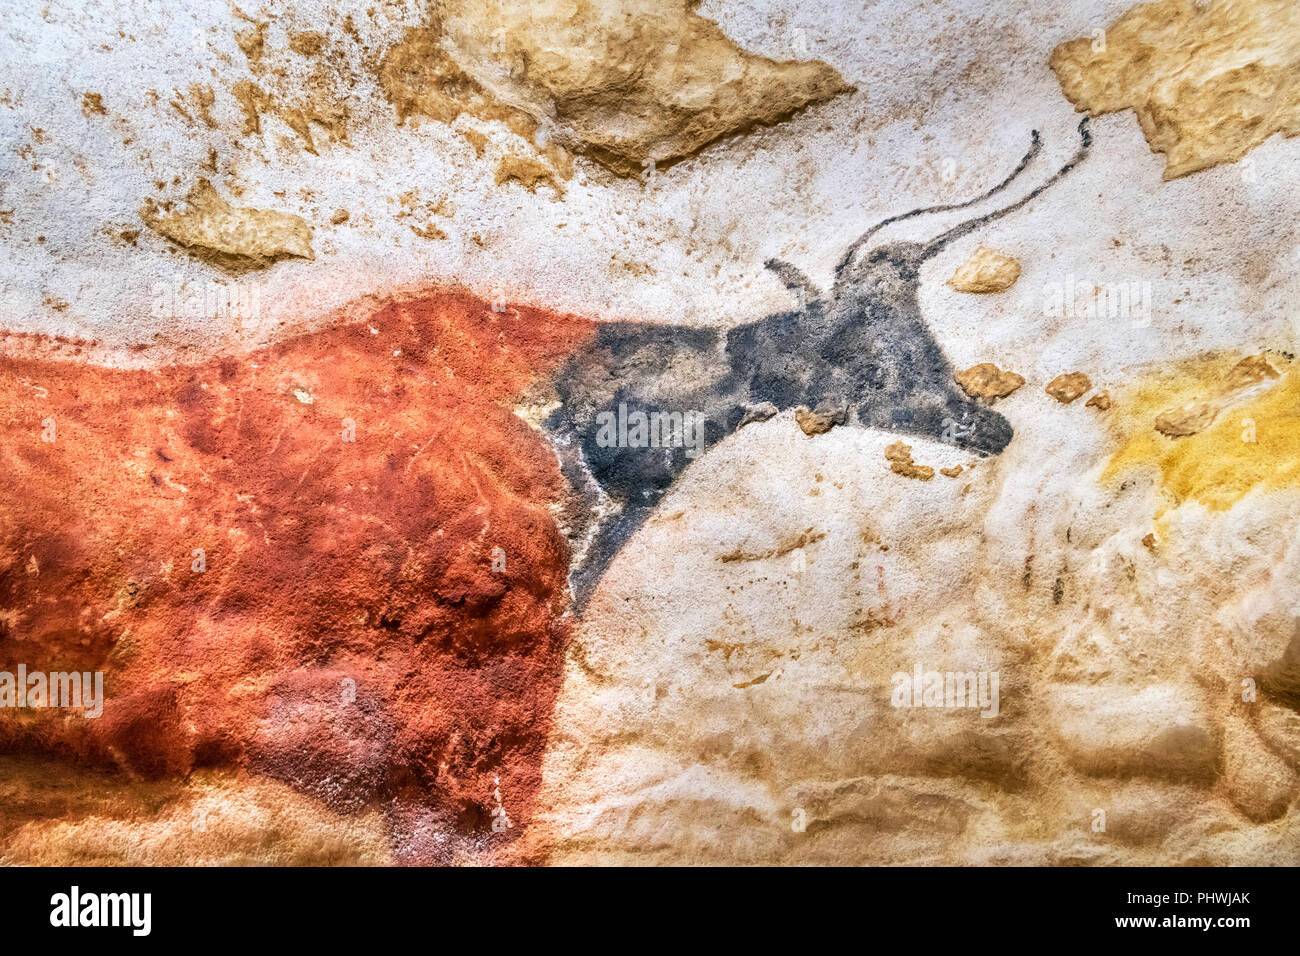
[1050,0,1300,179]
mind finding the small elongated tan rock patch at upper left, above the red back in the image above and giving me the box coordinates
[140,179,316,273]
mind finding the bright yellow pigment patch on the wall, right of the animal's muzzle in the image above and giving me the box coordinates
[1101,352,1300,518]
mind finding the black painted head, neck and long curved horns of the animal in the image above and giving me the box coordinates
[545,120,1092,610]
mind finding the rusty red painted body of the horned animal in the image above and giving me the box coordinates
[0,293,592,862]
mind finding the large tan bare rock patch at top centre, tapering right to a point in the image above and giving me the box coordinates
[442,0,850,177]
